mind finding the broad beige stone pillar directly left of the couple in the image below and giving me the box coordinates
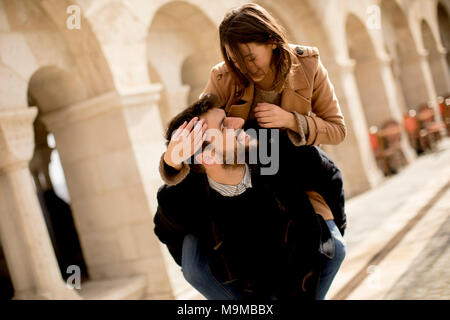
[42,85,173,299]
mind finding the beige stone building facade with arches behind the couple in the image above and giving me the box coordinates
[0,0,450,299]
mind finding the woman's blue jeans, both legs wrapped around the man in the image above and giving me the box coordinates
[181,220,345,300]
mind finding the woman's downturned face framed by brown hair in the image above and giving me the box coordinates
[225,42,276,83]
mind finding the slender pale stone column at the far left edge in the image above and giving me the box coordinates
[0,108,80,299]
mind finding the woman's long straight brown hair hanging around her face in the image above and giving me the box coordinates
[219,3,295,91]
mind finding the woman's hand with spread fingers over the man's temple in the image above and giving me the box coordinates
[164,117,208,170]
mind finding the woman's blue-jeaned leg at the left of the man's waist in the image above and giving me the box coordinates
[181,234,246,300]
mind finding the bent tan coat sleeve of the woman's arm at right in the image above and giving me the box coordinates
[305,58,347,145]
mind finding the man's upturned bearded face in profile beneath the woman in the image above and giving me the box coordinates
[200,108,250,164]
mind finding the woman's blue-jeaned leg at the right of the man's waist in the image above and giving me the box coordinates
[317,220,345,300]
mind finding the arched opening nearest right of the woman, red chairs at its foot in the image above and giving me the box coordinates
[346,14,407,175]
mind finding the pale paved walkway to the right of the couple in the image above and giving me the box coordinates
[327,138,450,299]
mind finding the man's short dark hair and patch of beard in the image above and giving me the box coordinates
[165,93,221,172]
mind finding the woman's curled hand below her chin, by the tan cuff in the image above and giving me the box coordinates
[254,103,297,131]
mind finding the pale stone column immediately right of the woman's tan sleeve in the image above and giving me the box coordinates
[327,59,383,196]
